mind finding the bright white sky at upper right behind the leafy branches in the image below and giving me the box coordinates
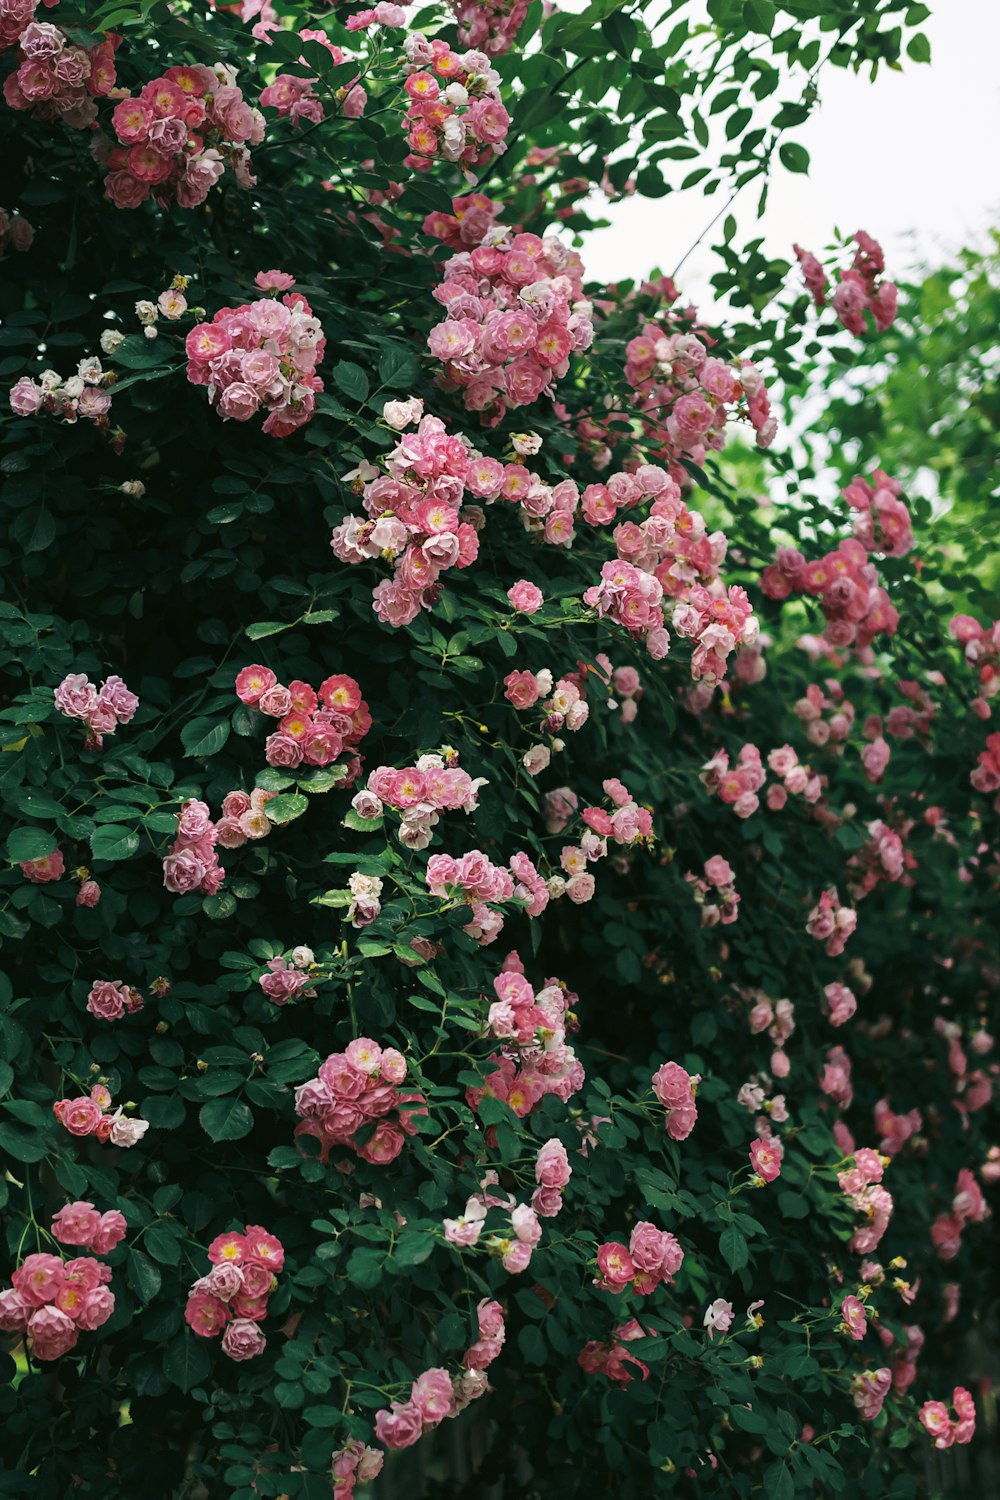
[578,0,1000,302]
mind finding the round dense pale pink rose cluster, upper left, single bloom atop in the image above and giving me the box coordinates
[184,272,327,438]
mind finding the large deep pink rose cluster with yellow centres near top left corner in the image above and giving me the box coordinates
[103,63,264,209]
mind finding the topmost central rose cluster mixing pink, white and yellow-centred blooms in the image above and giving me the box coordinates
[403,32,510,173]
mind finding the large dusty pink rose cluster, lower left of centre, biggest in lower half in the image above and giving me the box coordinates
[295,1037,426,1167]
